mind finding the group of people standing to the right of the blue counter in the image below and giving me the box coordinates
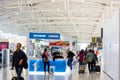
[67,49,98,72]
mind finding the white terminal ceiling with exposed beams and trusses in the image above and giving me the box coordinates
[0,0,120,42]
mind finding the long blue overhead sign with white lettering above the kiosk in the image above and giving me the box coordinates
[29,33,60,39]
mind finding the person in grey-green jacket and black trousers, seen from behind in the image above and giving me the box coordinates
[86,50,95,72]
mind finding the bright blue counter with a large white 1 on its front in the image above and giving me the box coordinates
[29,59,68,73]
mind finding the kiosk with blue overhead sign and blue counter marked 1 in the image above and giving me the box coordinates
[28,33,69,75]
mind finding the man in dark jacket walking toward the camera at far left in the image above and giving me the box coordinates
[11,43,27,80]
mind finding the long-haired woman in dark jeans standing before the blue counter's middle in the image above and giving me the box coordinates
[42,48,50,74]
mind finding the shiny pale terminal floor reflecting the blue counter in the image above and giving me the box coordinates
[0,66,111,80]
